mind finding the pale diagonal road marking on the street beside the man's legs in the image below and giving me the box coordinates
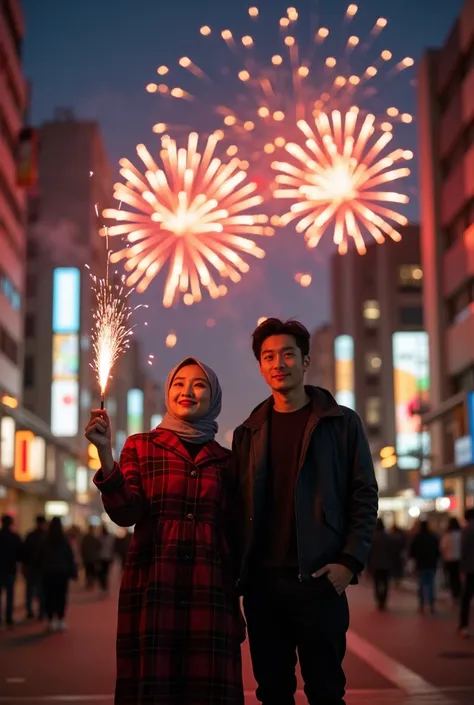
[347,631,448,702]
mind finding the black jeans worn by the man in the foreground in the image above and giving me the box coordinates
[244,571,349,705]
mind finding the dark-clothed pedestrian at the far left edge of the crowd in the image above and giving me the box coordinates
[0,514,23,627]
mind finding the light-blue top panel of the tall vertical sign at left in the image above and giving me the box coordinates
[53,267,81,333]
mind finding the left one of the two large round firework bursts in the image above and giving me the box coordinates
[102,132,274,307]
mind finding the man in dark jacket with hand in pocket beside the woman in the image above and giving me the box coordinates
[233,318,377,705]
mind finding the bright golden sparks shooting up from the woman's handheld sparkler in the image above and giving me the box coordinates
[91,275,135,406]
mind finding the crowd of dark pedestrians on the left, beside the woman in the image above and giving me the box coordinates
[0,514,131,632]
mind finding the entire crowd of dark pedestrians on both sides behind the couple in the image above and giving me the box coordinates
[0,509,474,637]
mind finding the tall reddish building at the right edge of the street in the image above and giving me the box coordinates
[417,0,474,513]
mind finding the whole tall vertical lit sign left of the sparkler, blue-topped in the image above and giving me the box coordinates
[51,267,81,438]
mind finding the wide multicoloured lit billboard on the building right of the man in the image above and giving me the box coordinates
[392,331,430,470]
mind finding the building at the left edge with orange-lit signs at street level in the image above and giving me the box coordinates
[0,0,88,533]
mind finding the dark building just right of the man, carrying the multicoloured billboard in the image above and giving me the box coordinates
[332,225,429,524]
